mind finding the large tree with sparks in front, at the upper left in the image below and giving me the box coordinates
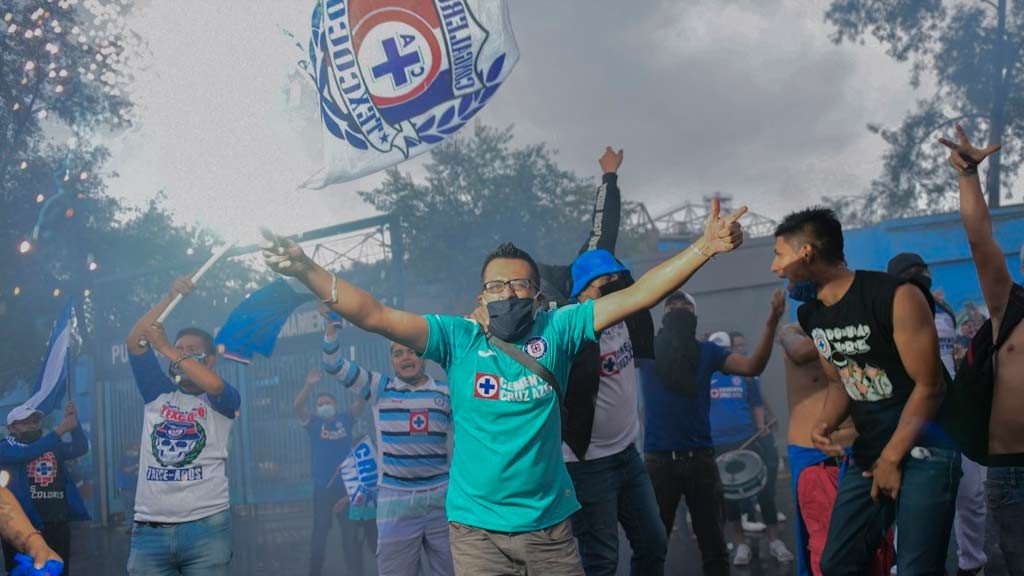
[0,0,251,394]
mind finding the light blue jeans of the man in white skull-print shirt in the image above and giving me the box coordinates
[128,510,231,576]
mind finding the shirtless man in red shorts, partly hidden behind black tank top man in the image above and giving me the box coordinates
[778,322,860,576]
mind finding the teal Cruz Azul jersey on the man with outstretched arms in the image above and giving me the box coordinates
[424,301,595,532]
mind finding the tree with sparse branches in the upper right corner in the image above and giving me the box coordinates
[825,0,1024,221]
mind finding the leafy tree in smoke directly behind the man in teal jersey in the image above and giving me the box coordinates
[359,124,647,307]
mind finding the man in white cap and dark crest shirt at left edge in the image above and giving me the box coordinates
[0,402,89,574]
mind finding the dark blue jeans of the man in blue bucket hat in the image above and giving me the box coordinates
[565,445,669,576]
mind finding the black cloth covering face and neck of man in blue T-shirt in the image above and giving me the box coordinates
[654,308,700,398]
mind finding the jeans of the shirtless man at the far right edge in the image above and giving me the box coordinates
[985,466,1024,576]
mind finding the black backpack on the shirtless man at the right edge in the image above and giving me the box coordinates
[952,284,1024,466]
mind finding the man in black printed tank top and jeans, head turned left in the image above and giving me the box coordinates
[772,209,961,576]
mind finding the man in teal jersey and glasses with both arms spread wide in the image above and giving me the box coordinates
[263,200,746,576]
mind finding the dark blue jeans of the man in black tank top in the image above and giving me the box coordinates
[821,448,962,576]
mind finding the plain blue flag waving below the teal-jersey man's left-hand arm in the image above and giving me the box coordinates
[215,279,314,364]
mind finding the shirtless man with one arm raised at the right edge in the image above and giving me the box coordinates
[940,126,1024,576]
